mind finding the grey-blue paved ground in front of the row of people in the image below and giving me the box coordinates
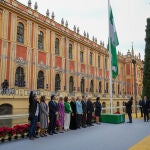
[0,119,150,150]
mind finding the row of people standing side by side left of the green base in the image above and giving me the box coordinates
[29,91,101,140]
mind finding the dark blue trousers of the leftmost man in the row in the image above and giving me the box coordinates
[29,116,38,138]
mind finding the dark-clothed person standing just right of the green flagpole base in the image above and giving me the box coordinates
[125,96,133,123]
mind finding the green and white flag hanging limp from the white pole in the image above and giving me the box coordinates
[108,6,119,79]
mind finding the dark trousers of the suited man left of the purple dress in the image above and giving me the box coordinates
[48,114,56,133]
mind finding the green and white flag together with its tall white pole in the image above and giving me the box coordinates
[108,0,119,114]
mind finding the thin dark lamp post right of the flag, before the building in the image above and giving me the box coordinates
[132,59,137,118]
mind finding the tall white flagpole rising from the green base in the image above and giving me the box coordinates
[108,0,113,114]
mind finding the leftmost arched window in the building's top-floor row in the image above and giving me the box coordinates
[17,22,24,43]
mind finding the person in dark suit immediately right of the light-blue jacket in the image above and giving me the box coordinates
[81,96,87,128]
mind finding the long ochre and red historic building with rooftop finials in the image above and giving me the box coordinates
[0,0,143,121]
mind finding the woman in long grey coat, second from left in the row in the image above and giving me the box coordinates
[40,96,48,137]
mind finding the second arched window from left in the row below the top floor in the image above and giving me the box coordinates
[37,71,44,89]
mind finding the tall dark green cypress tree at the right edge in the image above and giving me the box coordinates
[142,18,150,99]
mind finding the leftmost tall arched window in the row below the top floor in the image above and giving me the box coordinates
[15,67,25,87]
